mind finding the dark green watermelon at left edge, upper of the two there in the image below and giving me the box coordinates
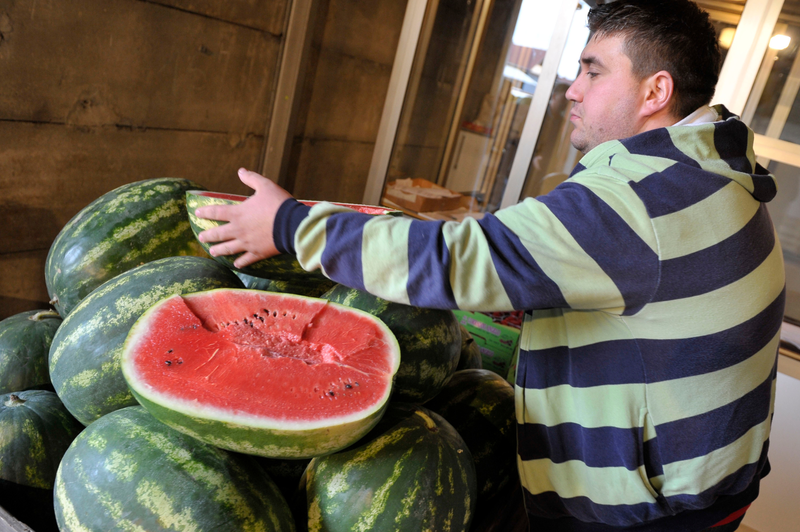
[0,310,61,393]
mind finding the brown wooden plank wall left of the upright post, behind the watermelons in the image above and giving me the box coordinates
[0,0,289,319]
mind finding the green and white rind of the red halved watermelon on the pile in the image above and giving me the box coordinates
[121,289,400,459]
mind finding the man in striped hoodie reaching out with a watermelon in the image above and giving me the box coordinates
[199,0,784,532]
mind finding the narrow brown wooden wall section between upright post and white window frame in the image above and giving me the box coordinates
[287,0,408,203]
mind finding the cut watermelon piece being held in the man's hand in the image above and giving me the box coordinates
[186,190,402,283]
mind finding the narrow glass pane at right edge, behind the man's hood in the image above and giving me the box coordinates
[767,161,800,321]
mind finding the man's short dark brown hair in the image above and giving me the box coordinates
[589,0,721,118]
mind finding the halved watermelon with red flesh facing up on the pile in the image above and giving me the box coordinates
[122,289,400,458]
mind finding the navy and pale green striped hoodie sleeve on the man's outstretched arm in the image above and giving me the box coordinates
[275,178,658,314]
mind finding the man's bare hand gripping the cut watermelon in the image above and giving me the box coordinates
[197,168,292,268]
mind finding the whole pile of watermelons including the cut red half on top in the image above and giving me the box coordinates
[0,178,527,532]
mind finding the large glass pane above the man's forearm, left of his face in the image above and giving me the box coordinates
[382,0,588,219]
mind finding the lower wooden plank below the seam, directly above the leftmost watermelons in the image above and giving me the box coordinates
[0,122,263,253]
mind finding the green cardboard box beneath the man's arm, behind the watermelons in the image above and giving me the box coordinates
[453,310,520,379]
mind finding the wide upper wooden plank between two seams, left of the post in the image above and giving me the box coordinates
[0,0,281,134]
